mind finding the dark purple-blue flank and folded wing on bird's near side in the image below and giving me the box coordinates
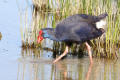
[55,22,102,42]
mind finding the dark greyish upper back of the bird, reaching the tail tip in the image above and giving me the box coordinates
[57,13,108,25]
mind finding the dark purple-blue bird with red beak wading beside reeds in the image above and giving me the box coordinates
[37,13,108,63]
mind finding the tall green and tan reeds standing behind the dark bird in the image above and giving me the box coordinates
[20,0,120,58]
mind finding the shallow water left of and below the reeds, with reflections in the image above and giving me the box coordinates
[0,0,120,80]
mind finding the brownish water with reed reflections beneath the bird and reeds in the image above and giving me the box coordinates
[17,50,120,80]
